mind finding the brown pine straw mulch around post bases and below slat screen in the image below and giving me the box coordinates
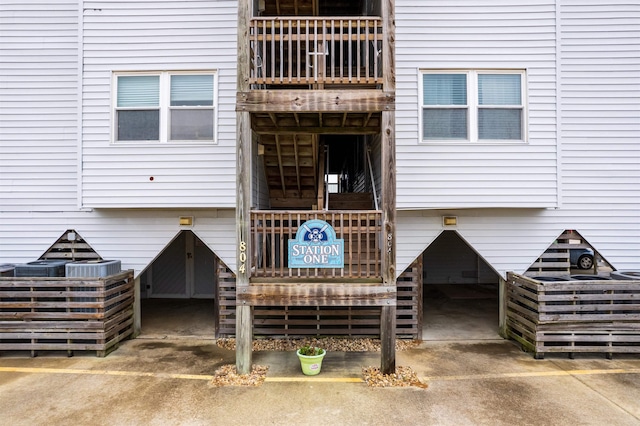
[211,338,427,389]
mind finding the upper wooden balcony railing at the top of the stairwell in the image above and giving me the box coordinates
[249,17,382,85]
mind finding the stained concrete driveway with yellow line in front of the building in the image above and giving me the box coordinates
[0,338,640,426]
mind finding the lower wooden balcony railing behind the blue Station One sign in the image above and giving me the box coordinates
[251,210,382,281]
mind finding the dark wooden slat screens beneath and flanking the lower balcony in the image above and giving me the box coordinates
[216,261,422,339]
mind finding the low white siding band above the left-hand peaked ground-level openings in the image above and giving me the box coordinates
[0,209,236,275]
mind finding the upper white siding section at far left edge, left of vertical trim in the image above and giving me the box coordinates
[0,0,79,211]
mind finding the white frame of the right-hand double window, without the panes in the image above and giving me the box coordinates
[418,69,529,145]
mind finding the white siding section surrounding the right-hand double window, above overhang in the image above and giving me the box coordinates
[396,0,559,210]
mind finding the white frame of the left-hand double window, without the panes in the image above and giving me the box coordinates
[111,70,218,145]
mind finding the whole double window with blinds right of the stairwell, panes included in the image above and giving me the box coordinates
[420,70,526,142]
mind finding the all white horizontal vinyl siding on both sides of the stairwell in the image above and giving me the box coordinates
[0,0,640,280]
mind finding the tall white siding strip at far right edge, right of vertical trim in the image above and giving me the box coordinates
[558,0,640,269]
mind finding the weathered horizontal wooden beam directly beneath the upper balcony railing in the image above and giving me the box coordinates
[236,90,395,113]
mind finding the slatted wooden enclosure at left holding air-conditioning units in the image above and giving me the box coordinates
[0,270,134,356]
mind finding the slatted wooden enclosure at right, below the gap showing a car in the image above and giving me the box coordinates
[505,273,640,359]
